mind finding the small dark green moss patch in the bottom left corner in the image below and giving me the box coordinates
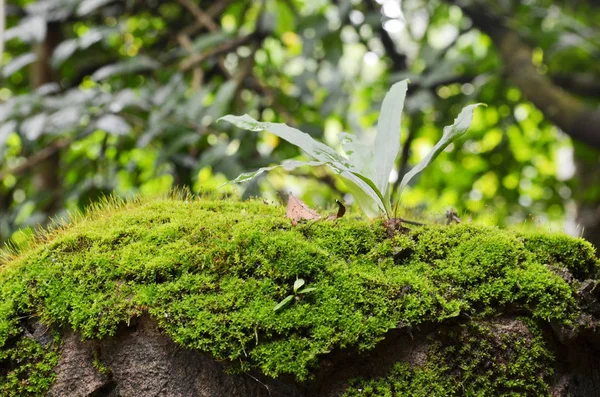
[0,333,60,397]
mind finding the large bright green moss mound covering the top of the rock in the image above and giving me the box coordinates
[0,199,598,395]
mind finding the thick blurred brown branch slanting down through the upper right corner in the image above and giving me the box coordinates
[448,0,600,149]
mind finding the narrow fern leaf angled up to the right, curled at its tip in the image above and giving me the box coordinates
[398,103,486,197]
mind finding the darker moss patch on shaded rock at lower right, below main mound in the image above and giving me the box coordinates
[344,319,553,397]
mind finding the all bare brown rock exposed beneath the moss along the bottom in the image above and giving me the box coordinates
[48,316,600,397]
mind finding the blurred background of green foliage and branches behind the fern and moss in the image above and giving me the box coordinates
[0,0,600,251]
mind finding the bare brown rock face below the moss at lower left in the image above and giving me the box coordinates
[48,316,302,397]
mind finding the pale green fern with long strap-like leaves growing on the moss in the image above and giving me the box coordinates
[219,80,482,219]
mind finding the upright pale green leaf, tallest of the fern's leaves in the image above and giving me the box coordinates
[374,80,408,194]
